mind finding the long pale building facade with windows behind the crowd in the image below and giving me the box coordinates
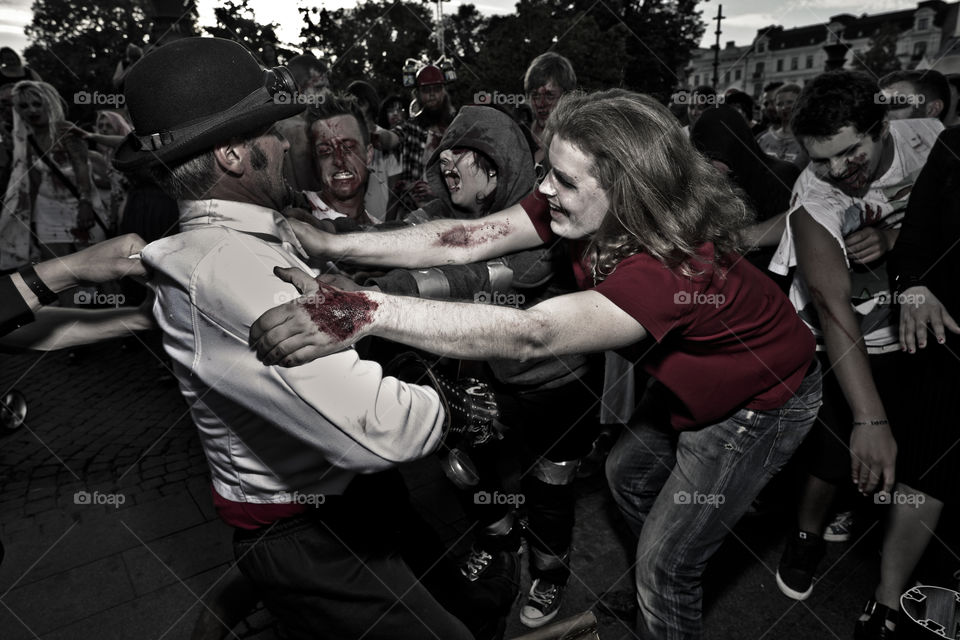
[684,0,960,97]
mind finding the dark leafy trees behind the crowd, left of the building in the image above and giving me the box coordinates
[26,0,704,122]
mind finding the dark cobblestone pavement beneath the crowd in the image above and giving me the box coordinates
[0,334,952,640]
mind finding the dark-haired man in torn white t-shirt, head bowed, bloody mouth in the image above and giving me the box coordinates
[770,71,943,600]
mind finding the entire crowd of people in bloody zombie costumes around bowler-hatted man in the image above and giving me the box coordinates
[0,32,960,640]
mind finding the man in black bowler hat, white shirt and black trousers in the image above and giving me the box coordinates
[115,38,488,640]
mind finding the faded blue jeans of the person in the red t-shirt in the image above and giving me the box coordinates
[607,363,821,640]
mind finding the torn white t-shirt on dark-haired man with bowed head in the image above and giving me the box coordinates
[769,118,943,353]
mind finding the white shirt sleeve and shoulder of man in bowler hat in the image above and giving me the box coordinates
[143,229,445,472]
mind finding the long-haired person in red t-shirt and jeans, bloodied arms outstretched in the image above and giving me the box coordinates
[251,91,820,638]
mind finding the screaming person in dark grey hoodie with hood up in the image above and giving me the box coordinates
[365,106,598,627]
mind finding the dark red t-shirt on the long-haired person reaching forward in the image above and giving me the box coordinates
[521,192,815,429]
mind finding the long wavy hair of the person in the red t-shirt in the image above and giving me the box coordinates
[546,89,753,280]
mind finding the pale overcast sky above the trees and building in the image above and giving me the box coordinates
[0,0,917,57]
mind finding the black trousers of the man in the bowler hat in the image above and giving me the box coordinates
[234,472,473,640]
